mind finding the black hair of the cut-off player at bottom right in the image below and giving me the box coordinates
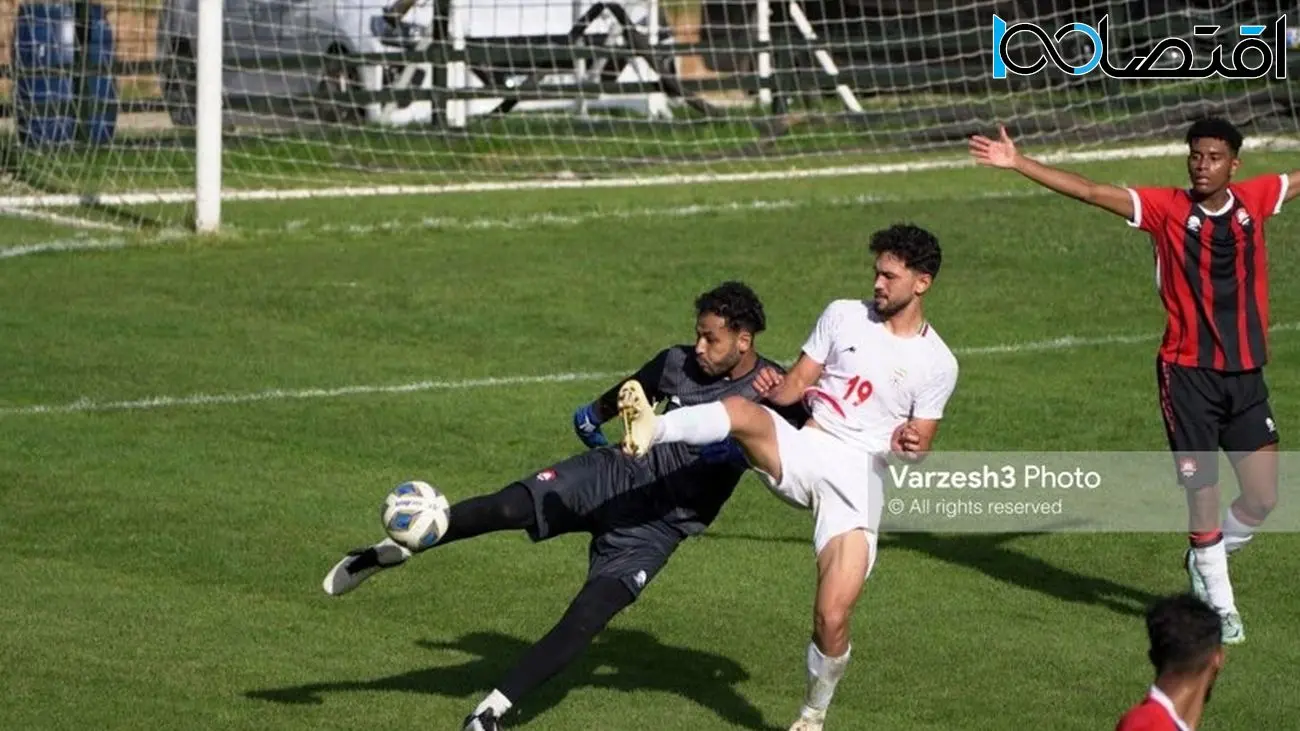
[1147,593,1223,675]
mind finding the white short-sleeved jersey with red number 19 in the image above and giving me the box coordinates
[803,299,957,453]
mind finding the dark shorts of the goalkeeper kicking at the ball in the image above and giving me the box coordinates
[519,446,683,597]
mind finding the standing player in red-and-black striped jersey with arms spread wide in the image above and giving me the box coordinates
[970,118,1300,643]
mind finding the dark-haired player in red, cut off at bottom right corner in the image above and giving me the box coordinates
[1115,594,1223,731]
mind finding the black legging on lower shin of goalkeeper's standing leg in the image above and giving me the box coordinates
[497,576,636,705]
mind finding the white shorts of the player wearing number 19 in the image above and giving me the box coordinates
[754,406,884,574]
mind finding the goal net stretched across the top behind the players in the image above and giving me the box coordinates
[0,0,1300,226]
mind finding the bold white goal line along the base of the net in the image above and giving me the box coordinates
[0,135,1300,208]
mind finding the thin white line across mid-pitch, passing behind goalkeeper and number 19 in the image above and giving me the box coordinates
[0,323,1300,416]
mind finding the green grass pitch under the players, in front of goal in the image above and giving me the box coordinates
[0,149,1300,731]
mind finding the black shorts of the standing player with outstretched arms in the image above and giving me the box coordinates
[1156,360,1278,488]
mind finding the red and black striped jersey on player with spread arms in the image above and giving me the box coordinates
[1128,174,1287,372]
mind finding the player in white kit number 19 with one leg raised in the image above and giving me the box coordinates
[619,224,957,731]
